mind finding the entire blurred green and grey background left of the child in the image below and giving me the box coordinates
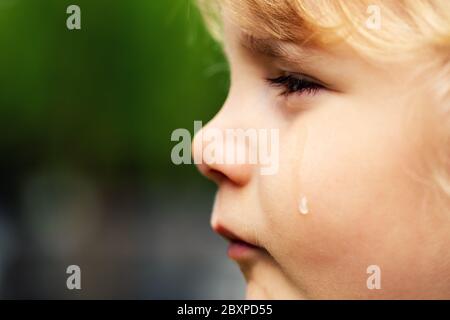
[0,0,244,299]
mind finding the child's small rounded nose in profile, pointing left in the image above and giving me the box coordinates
[192,109,254,186]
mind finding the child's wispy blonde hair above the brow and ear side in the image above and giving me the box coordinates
[197,0,450,205]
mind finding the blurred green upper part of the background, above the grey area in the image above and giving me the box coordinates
[0,0,227,181]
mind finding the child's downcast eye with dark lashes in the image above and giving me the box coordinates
[267,74,325,96]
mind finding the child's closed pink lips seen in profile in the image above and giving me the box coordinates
[213,225,267,261]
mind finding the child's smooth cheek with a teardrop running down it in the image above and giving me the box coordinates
[260,104,428,296]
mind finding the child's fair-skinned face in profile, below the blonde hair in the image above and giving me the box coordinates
[194,16,450,298]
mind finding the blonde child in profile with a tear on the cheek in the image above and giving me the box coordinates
[193,0,450,299]
